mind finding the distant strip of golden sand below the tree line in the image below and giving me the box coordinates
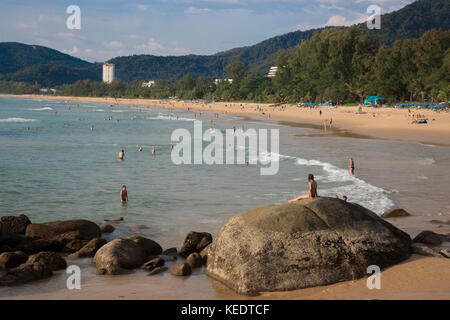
[0,94,450,146]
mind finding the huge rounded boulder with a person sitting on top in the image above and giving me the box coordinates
[206,198,411,295]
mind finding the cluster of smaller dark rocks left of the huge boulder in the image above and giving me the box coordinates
[0,215,212,286]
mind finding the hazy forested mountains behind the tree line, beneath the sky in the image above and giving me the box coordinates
[0,0,450,86]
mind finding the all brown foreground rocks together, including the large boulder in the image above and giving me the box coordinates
[0,197,450,295]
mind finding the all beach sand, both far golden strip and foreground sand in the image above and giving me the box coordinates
[0,95,450,300]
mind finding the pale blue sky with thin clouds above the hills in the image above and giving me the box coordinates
[0,0,414,62]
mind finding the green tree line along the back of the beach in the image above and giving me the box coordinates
[0,27,450,104]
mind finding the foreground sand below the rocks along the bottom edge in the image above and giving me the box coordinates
[0,255,450,300]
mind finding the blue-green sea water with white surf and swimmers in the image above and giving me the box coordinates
[0,98,394,247]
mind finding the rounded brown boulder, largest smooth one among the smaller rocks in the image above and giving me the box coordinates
[94,238,147,274]
